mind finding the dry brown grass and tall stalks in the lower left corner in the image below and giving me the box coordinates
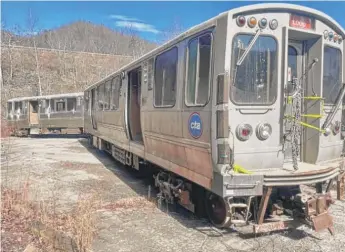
[1,139,101,252]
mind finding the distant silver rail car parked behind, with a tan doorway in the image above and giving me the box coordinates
[7,93,84,135]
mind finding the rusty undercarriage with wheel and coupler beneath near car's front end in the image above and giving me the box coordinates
[154,167,345,234]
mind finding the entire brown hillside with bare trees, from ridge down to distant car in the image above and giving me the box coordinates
[1,22,157,114]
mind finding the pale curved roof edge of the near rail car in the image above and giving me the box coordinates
[84,3,345,91]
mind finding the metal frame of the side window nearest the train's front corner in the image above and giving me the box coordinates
[184,30,214,108]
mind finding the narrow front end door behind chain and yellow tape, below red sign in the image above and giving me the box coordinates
[284,40,304,162]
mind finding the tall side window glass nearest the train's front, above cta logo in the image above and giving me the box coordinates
[185,33,212,106]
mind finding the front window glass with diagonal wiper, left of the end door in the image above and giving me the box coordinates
[230,34,278,105]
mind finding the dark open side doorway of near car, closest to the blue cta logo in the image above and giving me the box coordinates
[127,67,144,144]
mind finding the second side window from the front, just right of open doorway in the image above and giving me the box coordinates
[154,47,178,107]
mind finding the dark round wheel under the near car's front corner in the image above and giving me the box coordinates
[205,192,231,228]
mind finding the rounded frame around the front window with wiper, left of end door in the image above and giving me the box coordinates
[228,32,280,107]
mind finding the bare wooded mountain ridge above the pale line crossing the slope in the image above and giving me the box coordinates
[2,21,157,56]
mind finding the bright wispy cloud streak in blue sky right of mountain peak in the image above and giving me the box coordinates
[109,15,160,34]
